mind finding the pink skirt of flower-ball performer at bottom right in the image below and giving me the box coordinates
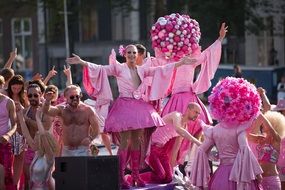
[209,165,262,190]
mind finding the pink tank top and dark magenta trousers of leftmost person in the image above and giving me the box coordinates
[0,97,16,190]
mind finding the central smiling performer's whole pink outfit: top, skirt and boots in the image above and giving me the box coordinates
[83,50,175,187]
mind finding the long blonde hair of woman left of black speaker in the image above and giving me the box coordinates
[38,131,59,156]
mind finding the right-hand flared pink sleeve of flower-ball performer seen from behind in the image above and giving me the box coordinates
[229,130,263,189]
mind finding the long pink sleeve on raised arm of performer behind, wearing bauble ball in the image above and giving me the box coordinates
[192,40,222,94]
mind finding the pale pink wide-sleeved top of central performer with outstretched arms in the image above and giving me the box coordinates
[83,50,175,106]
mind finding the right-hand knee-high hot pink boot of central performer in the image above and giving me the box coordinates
[131,150,145,187]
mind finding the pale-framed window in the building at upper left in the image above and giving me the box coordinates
[12,18,33,71]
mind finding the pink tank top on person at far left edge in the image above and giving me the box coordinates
[0,96,10,136]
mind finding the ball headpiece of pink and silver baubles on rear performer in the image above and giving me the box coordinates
[151,13,201,60]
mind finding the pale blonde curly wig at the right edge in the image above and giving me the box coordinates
[264,111,285,138]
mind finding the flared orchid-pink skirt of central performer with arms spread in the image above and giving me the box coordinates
[104,97,165,133]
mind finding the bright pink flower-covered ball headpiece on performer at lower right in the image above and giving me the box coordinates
[209,77,261,126]
